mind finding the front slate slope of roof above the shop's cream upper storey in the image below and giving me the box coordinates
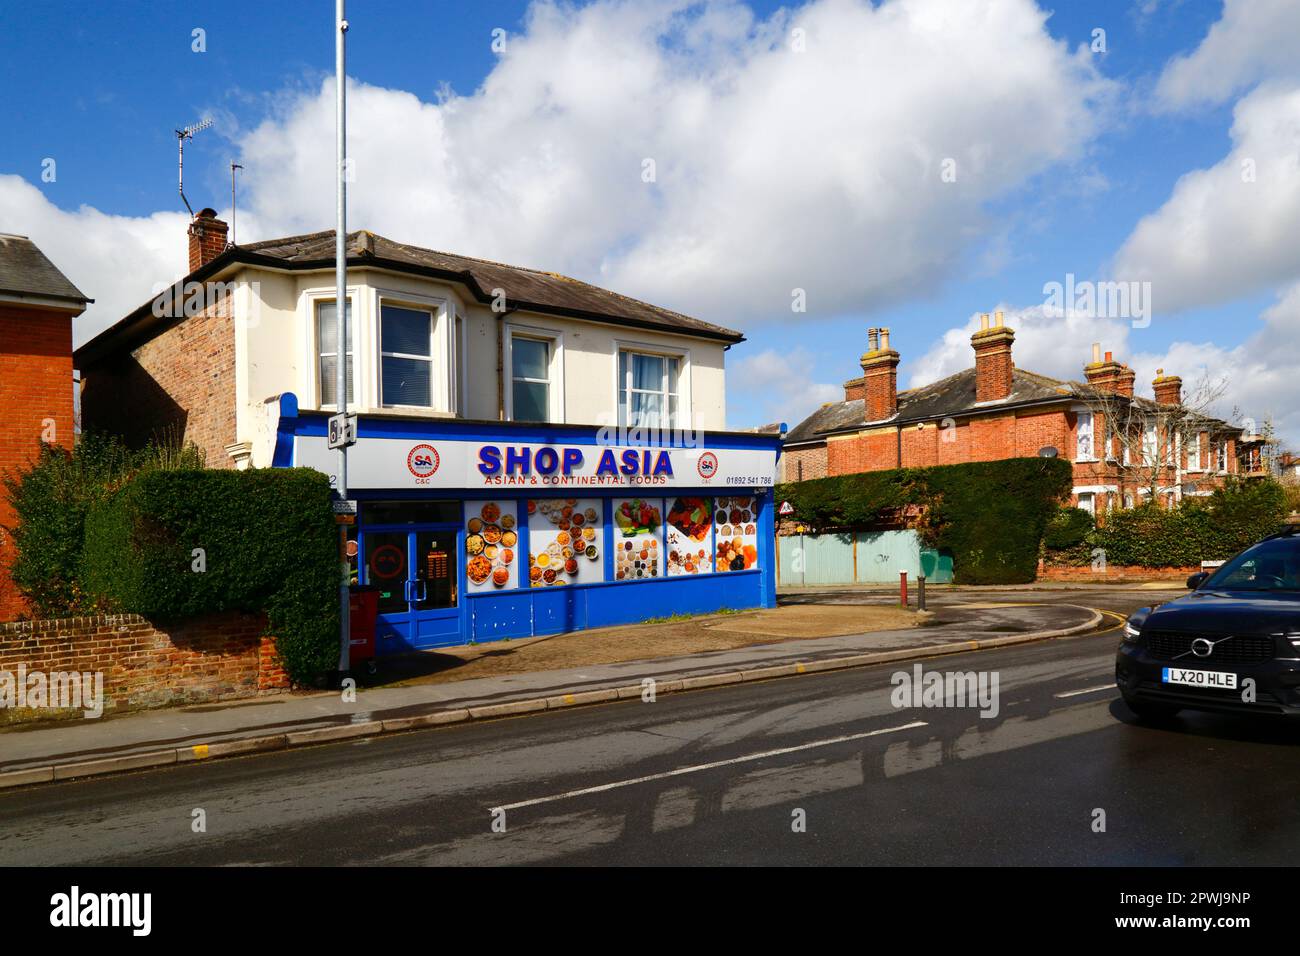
[241,232,745,342]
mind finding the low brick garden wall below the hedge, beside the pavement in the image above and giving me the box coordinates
[0,611,289,721]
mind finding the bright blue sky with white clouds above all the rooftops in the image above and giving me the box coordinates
[0,0,1300,438]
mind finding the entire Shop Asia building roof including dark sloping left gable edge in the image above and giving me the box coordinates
[77,230,745,364]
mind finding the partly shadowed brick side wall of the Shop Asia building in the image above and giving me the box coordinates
[82,297,237,468]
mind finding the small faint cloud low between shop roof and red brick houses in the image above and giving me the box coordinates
[727,349,837,428]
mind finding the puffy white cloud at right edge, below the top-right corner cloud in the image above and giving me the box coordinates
[1114,85,1300,312]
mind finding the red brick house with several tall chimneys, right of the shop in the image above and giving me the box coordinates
[783,312,1242,515]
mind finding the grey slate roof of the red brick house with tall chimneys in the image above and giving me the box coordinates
[785,368,1240,445]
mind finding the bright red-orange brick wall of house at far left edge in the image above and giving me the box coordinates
[0,304,75,620]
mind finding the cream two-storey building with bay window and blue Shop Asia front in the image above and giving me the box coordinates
[75,209,780,653]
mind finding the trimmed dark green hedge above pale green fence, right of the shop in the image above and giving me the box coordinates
[776,458,1071,584]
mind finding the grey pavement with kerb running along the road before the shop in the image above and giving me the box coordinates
[0,591,1114,790]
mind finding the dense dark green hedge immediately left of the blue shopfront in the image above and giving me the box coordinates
[82,468,341,684]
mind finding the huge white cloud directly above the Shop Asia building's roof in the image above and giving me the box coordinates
[223,0,1109,324]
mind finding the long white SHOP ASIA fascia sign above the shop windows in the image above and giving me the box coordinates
[294,434,776,490]
